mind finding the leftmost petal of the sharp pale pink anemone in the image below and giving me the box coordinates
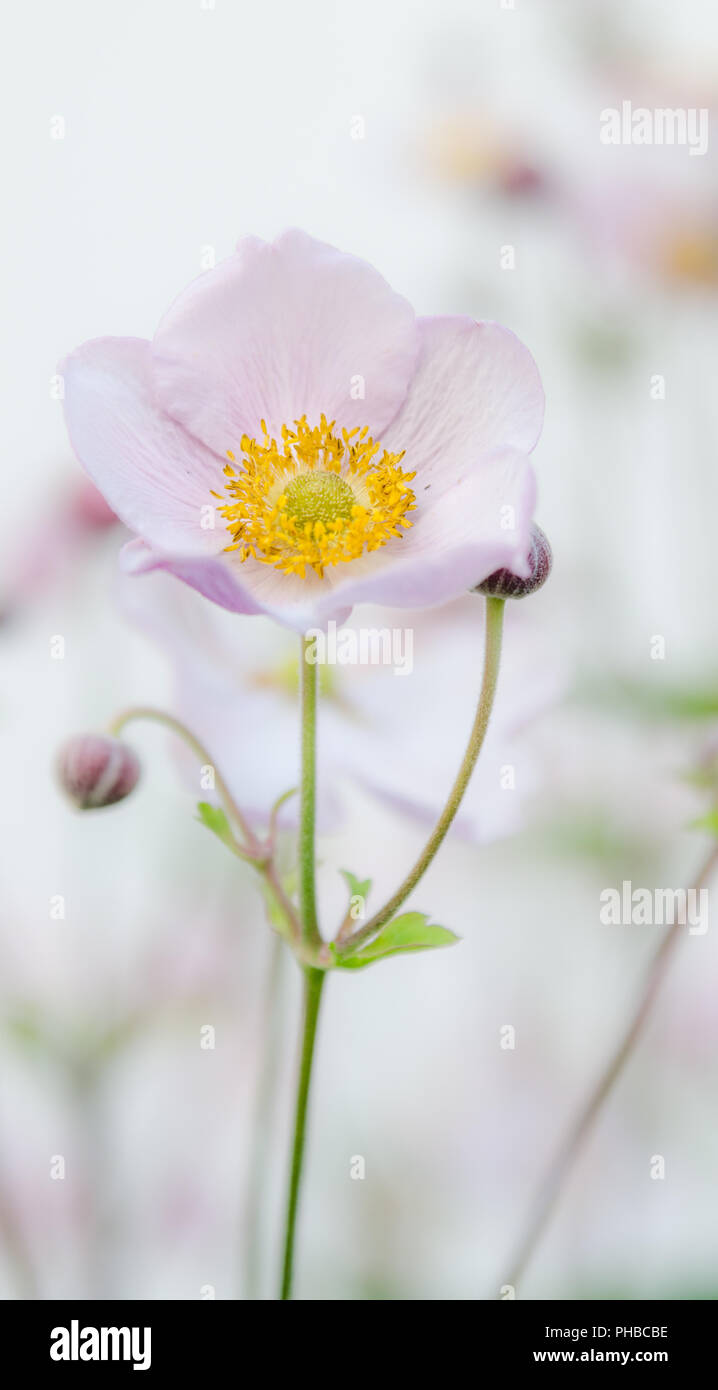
[61,338,226,555]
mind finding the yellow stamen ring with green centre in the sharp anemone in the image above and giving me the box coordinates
[212,416,415,578]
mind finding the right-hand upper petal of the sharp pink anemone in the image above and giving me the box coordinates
[382,317,543,500]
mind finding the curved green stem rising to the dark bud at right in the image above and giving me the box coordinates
[336,598,504,952]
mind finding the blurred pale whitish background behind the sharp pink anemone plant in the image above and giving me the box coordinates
[0,0,718,1300]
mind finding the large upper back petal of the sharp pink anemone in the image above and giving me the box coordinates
[153,231,418,456]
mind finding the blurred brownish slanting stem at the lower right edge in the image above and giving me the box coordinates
[507,845,718,1289]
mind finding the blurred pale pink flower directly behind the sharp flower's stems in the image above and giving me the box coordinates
[118,574,565,842]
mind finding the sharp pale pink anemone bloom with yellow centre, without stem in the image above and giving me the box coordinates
[62,231,543,630]
